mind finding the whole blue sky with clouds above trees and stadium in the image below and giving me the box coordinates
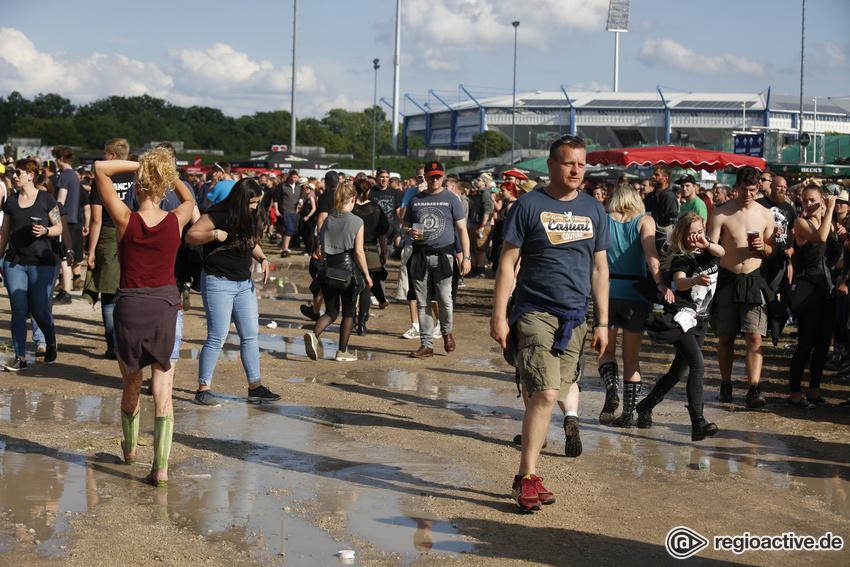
[0,0,850,118]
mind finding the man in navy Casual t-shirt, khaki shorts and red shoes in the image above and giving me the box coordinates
[490,135,611,511]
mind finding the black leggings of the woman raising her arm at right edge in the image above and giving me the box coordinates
[788,290,835,393]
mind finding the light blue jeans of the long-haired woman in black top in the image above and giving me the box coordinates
[198,271,260,386]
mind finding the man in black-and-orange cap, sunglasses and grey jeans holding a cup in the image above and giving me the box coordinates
[402,161,472,358]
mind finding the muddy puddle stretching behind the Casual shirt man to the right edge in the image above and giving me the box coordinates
[338,360,850,518]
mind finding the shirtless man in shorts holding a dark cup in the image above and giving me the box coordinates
[708,166,776,408]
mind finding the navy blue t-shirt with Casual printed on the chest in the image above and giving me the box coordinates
[502,187,611,309]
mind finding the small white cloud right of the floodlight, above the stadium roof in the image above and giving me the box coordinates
[640,38,768,77]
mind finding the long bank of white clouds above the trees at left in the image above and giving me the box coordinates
[0,28,327,116]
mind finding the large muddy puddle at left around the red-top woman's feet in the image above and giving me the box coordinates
[0,391,472,565]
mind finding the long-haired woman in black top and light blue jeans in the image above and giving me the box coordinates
[186,178,280,407]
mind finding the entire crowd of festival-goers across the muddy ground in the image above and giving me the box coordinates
[0,136,850,511]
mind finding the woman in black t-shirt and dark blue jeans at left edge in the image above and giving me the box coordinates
[0,159,62,372]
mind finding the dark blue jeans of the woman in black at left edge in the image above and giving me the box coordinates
[3,259,56,358]
